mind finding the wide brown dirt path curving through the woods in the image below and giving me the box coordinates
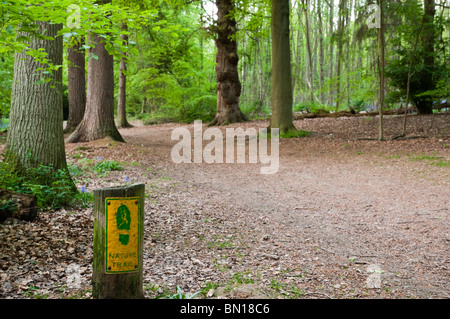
[117,115,449,298]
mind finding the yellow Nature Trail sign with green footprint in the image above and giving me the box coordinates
[105,197,139,274]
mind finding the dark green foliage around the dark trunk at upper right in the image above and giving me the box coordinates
[386,1,450,108]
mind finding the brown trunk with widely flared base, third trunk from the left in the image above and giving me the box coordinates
[66,0,124,143]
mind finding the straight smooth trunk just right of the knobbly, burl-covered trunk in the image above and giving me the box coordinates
[269,0,295,133]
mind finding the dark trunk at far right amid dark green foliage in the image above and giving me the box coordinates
[416,0,436,114]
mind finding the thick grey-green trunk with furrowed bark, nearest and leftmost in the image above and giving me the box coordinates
[5,22,67,174]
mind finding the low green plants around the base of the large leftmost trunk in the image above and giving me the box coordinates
[0,162,77,209]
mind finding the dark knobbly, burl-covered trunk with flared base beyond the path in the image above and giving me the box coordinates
[210,0,247,125]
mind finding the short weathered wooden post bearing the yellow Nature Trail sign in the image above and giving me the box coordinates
[92,184,145,299]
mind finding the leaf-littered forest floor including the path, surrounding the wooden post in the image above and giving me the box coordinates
[0,114,450,299]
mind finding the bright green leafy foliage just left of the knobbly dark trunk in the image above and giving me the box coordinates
[127,1,217,124]
